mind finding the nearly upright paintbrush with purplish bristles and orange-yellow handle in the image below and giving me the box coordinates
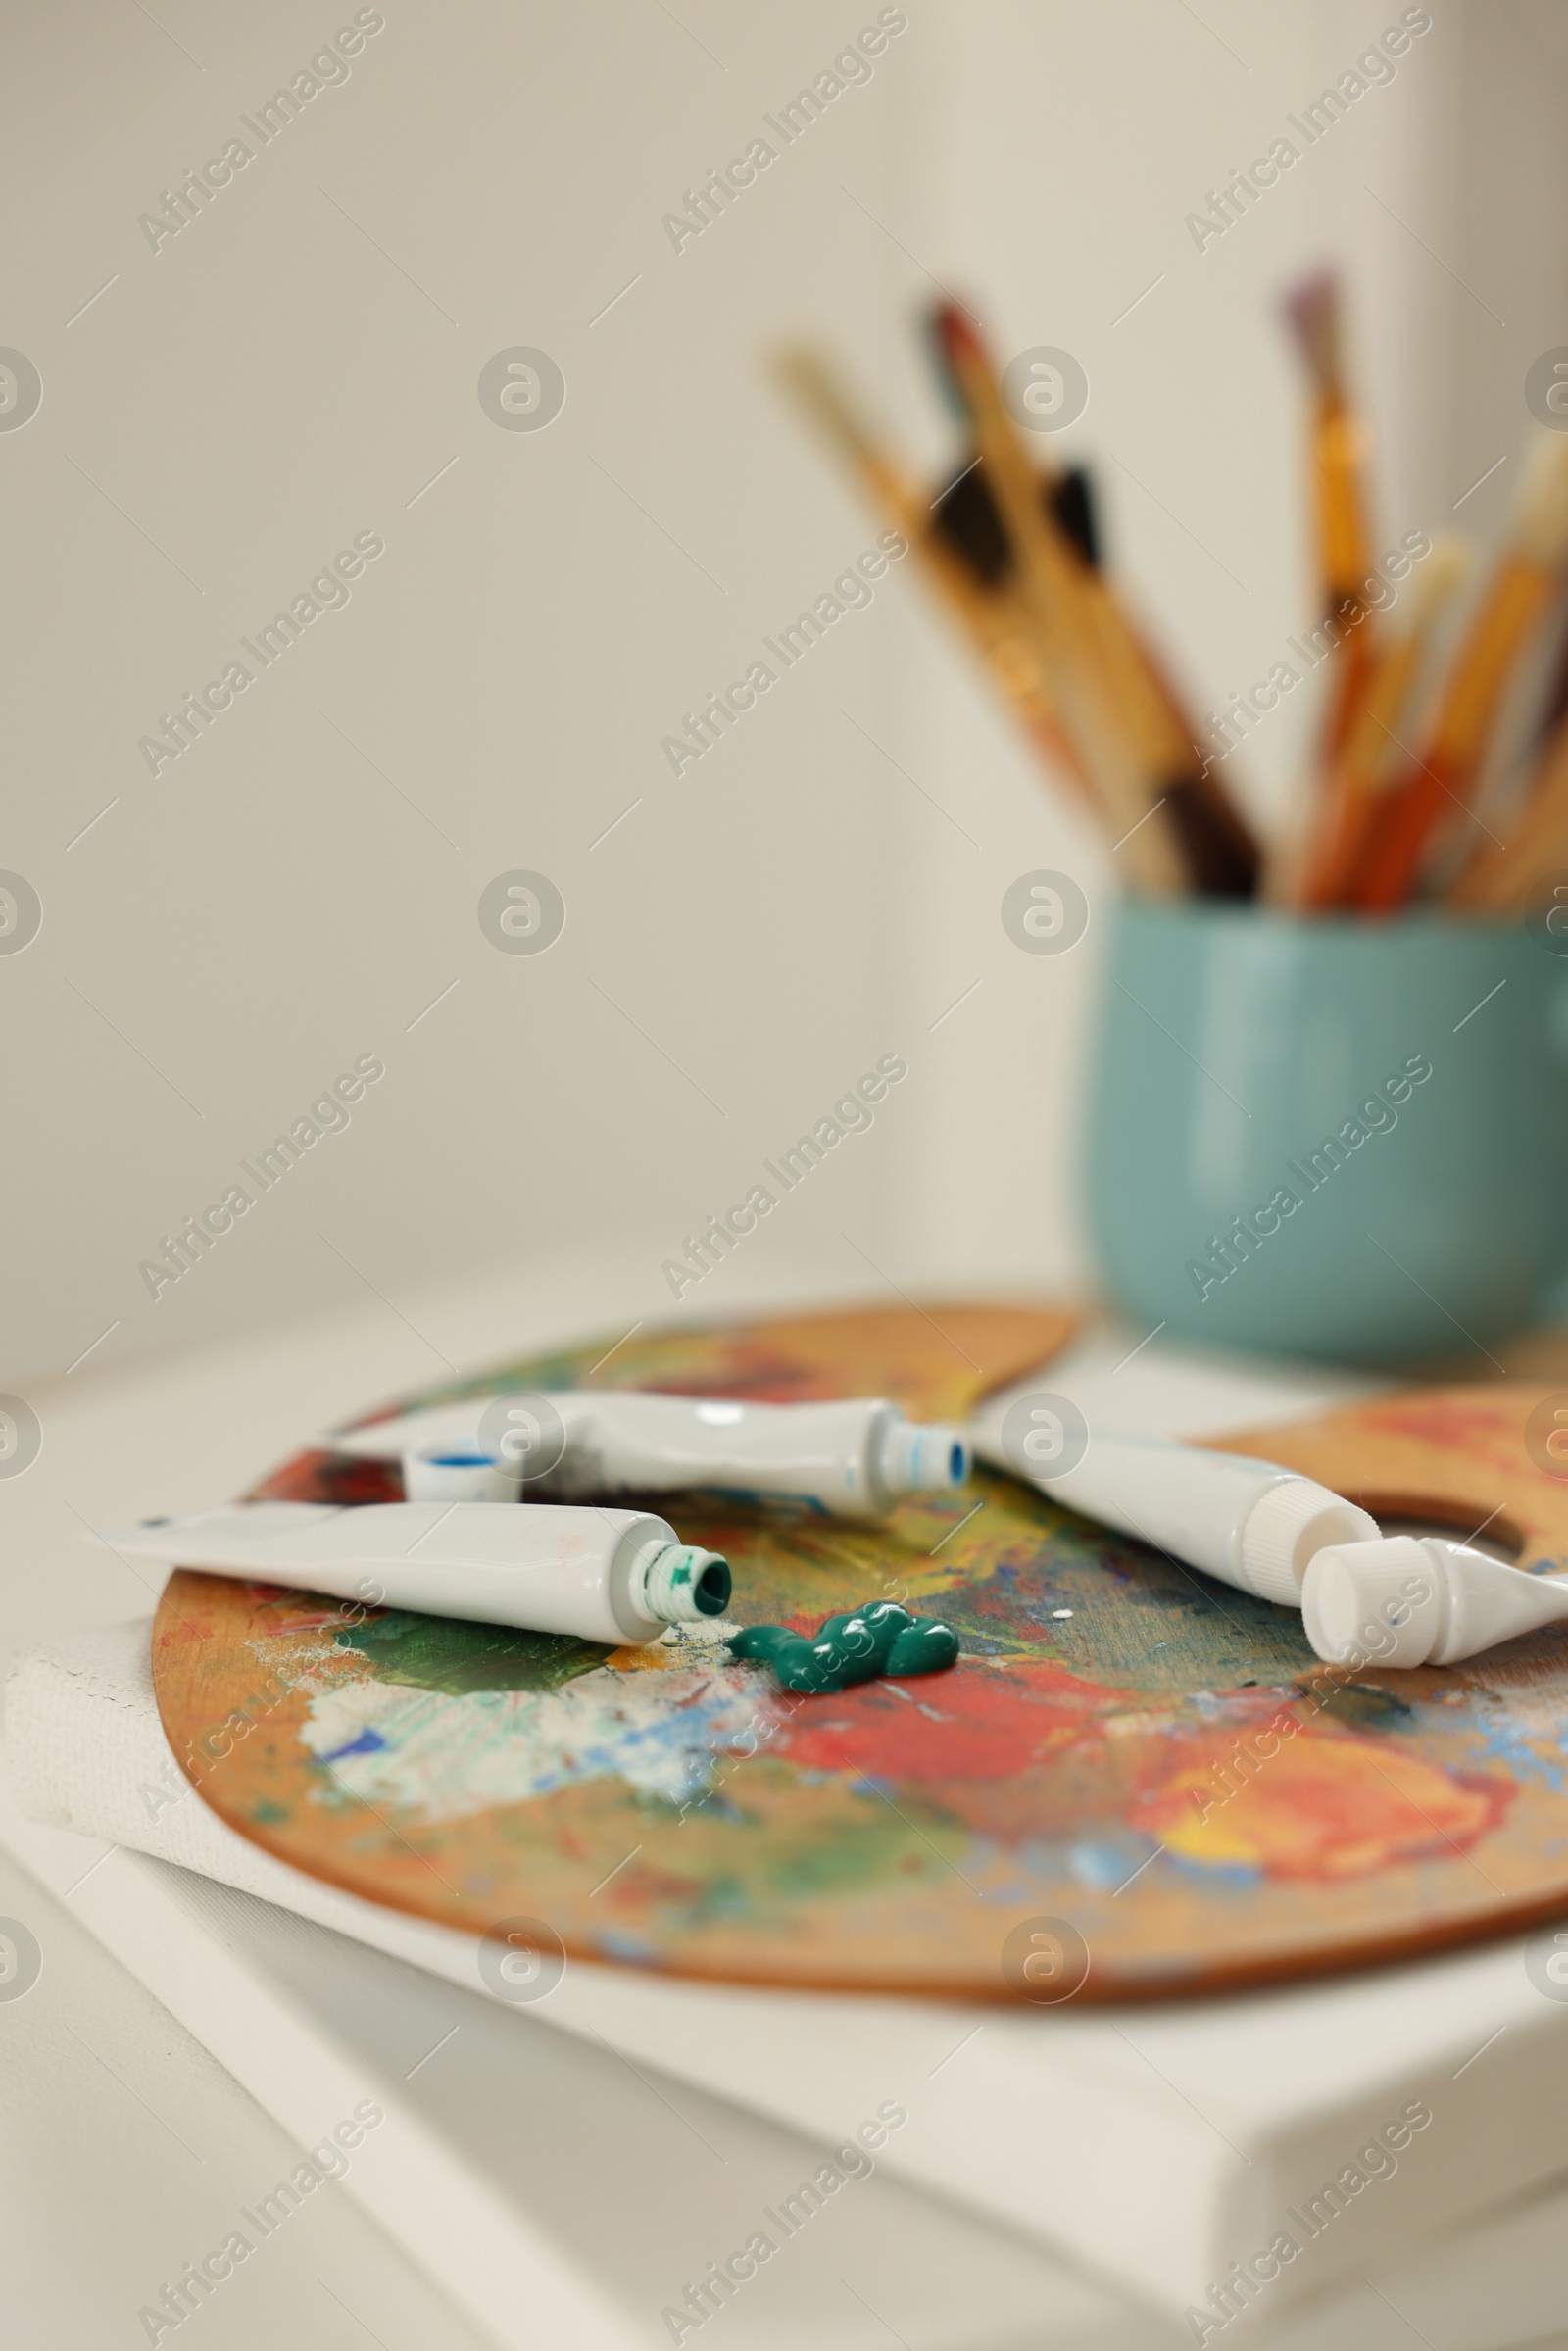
[1284,270,1378,776]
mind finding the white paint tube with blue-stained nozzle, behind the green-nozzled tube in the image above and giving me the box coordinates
[315,1390,968,1524]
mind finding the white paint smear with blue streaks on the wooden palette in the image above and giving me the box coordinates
[301,1664,773,1820]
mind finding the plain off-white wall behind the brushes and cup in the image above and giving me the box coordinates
[0,0,1568,1383]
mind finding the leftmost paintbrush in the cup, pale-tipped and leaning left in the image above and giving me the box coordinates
[773,348,1104,820]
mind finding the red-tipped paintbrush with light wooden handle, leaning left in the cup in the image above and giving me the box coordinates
[933,303,1257,896]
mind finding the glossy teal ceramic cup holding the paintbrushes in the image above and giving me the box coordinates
[1089,898,1568,1371]
